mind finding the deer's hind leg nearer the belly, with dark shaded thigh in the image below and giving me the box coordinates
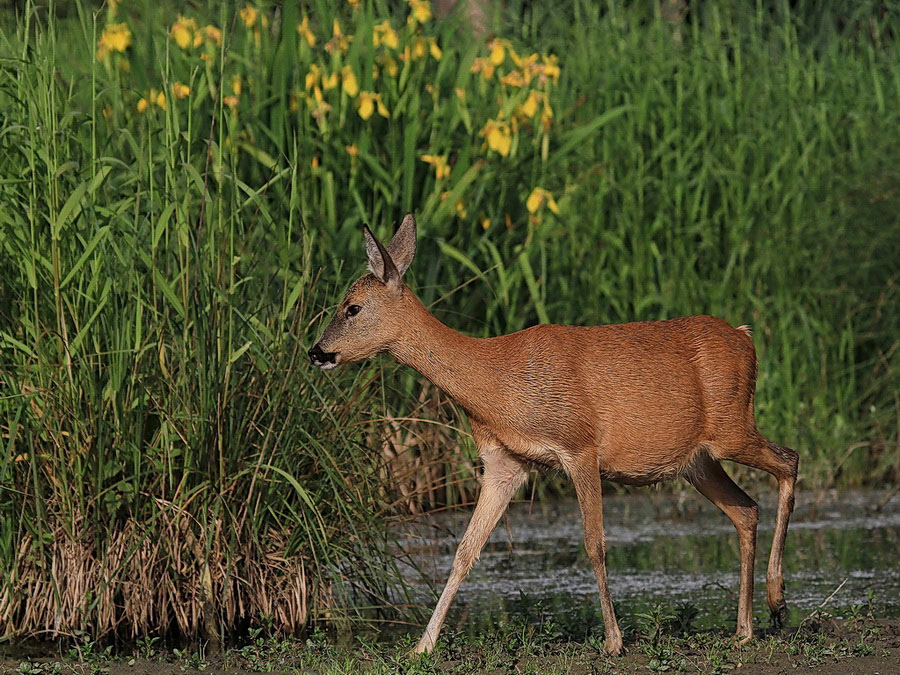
[685,453,759,642]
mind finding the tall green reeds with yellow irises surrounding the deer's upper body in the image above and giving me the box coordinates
[0,0,900,637]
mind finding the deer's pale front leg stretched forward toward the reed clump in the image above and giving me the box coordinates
[415,444,527,654]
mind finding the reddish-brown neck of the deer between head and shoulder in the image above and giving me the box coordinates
[390,299,497,420]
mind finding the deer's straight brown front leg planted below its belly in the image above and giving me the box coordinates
[569,465,622,656]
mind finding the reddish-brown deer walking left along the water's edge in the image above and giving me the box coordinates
[308,214,799,655]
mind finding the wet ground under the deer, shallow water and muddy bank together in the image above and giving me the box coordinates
[0,490,900,675]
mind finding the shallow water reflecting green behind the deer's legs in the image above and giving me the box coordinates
[403,488,900,631]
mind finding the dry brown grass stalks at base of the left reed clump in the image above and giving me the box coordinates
[0,508,316,638]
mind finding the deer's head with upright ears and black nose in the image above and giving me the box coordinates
[307,213,416,370]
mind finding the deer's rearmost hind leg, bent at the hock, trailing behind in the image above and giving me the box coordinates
[721,434,799,627]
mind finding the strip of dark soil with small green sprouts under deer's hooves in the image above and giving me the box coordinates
[0,617,900,675]
